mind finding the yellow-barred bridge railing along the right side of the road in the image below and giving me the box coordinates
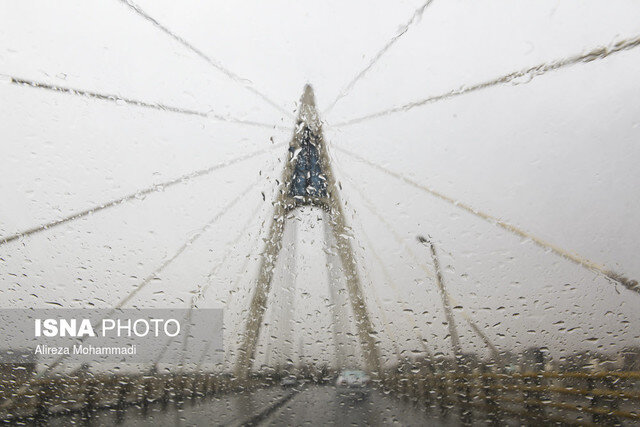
[382,370,640,424]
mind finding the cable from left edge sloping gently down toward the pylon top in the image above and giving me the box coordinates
[2,75,290,130]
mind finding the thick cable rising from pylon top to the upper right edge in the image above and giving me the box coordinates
[333,36,640,127]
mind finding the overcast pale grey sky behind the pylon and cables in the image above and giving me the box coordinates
[0,0,640,368]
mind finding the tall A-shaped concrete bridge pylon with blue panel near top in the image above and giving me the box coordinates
[235,85,380,379]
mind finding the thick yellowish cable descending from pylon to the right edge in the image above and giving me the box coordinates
[334,146,640,293]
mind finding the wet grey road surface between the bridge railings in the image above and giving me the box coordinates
[48,385,458,427]
